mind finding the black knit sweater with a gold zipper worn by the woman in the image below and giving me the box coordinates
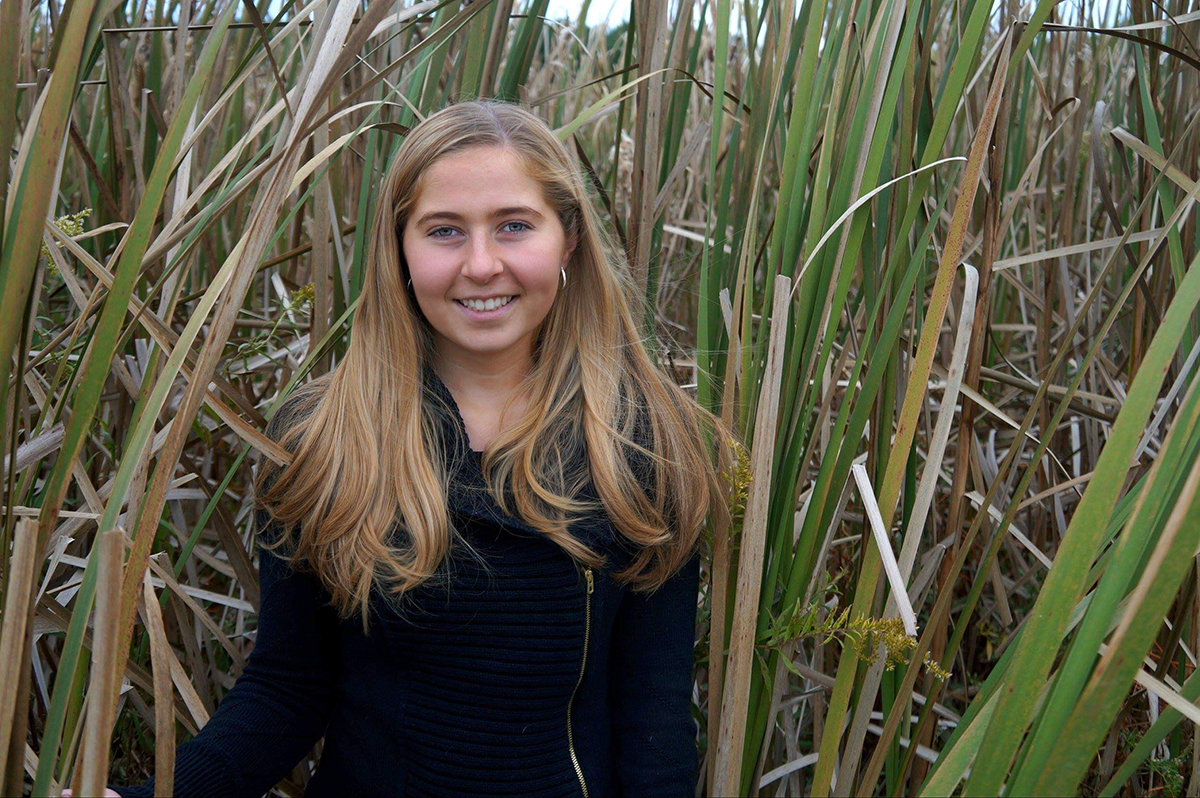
[114,367,700,798]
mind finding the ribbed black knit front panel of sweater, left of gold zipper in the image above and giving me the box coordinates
[383,470,586,798]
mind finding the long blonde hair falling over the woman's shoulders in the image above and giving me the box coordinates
[256,100,733,625]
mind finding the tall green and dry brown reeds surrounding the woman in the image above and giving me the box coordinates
[0,0,1200,796]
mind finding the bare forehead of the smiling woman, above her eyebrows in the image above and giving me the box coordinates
[414,146,545,215]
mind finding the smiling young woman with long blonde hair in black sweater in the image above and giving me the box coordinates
[96,101,732,798]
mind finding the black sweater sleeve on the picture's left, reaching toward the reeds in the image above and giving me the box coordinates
[112,509,337,798]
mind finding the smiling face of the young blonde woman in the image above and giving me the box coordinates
[402,146,572,360]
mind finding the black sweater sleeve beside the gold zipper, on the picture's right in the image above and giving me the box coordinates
[610,553,700,798]
